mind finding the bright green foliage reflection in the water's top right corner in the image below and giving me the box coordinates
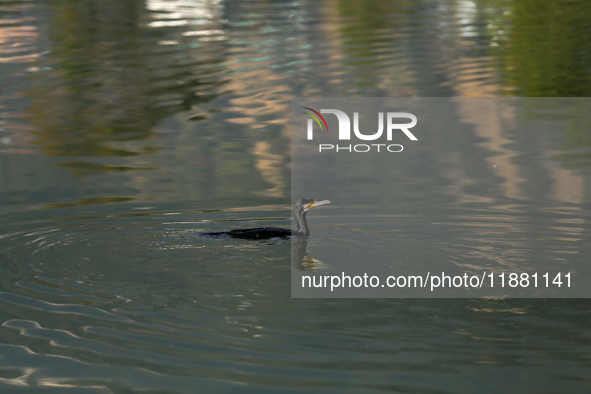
[494,0,591,97]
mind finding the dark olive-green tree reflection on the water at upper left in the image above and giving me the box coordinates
[26,1,224,168]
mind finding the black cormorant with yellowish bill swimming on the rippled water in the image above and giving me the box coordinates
[200,198,330,239]
